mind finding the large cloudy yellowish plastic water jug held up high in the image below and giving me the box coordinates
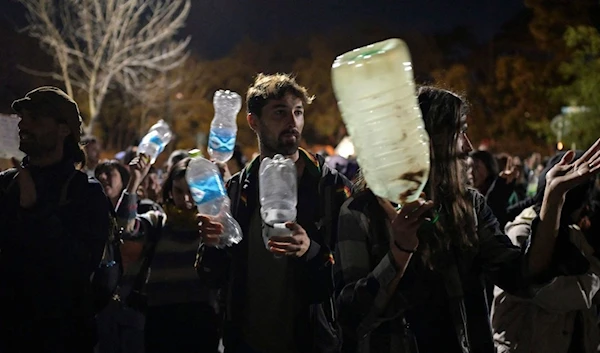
[332,39,430,205]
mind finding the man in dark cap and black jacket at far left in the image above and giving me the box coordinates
[0,87,111,353]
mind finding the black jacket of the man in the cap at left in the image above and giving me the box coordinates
[0,161,111,320]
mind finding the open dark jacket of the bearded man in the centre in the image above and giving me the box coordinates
[196,150,351,353]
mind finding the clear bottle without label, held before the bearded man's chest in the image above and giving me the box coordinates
[258,154,298,249]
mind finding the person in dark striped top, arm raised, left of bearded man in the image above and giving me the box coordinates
[100,156,220,353]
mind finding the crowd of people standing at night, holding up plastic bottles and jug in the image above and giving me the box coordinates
[0,74,600,353]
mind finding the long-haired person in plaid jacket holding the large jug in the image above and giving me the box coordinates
[335,87,600,353]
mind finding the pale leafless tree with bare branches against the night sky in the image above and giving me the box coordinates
[18,0,191,133]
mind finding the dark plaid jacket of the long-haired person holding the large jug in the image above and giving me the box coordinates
[335,190,589,353]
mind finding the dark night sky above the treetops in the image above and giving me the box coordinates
[0,0,524,58]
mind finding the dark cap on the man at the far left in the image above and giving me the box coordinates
[12,86,82,143]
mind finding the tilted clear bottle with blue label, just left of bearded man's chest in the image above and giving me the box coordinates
[185,157,242,248]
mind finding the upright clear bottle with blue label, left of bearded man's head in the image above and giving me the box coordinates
[208,90,242,163]
